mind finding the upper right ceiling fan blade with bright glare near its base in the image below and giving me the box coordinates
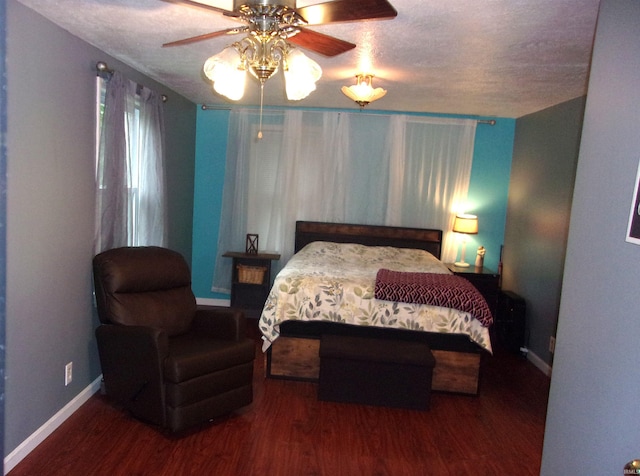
[296,0,398,25]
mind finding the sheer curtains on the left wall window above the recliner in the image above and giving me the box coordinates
[94,71,166,253]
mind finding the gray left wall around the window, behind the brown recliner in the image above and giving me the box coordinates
[5,0,196,455]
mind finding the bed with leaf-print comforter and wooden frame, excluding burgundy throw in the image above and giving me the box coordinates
[259,221,491,395]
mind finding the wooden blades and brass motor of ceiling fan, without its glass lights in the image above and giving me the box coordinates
[162,0,398,56]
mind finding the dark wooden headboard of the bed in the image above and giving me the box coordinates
[295,221,442,259]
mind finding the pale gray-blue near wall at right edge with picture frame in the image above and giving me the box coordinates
[542,0,640,470]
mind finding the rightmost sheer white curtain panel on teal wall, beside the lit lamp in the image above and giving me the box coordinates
[385,116,477,262]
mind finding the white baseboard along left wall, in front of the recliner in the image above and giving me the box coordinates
[4,375,102,474]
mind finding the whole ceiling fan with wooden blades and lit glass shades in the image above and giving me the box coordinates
[163,0,398,103]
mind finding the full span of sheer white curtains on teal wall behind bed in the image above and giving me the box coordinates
[212,110,476,292]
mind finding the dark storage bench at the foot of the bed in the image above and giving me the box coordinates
[318,335,435,410]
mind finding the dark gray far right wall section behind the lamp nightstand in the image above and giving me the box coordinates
[502,98,585,364]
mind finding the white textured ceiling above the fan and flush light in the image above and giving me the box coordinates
[19,0,599,118]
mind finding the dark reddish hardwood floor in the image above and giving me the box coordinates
[9,322,549,476]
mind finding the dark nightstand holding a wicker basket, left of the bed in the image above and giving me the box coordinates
[222,251,280,319]
